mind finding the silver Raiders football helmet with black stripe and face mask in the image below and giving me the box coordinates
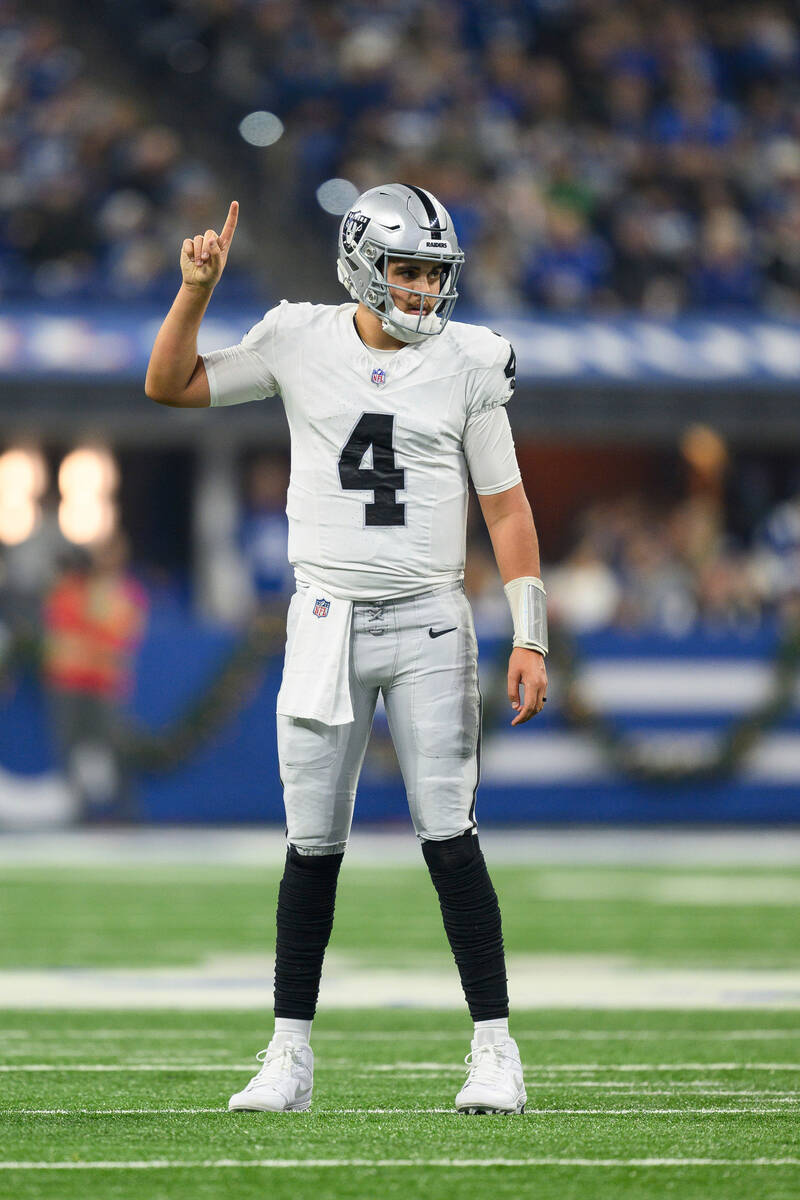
[337,184,464,342]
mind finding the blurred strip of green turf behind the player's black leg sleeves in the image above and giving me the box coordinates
[0,858,800,964]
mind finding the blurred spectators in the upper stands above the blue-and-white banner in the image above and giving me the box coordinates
[0,0,800,317]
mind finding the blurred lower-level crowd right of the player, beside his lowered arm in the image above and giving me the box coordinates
[467,492,800,637]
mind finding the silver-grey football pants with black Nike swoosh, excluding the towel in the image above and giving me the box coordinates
[277,583,481,854]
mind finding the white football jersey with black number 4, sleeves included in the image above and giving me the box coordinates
[204,300,521,600]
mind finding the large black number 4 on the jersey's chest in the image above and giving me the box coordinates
[339,413,405,526]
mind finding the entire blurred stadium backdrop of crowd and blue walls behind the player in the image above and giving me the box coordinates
[0,0,800,829]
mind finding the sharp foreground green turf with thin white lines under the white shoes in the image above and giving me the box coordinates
[0,1012,800,1200]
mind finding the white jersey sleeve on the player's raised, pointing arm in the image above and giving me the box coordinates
[203,301,285,408]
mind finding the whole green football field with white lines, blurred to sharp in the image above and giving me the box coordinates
[0,835,800,1200]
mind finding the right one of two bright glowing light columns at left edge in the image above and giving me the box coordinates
[59,446,119,546]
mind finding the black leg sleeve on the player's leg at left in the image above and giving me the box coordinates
[275,846,344,1021]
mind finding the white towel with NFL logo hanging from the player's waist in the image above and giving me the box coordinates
[277,583,353,725]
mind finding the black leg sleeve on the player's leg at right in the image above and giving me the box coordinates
[422,832,509,1021]
